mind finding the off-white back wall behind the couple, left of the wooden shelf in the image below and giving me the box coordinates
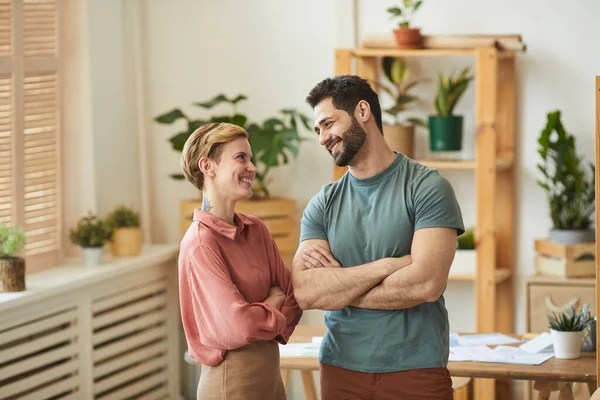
[146,0,344,241]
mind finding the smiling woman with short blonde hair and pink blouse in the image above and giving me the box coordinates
[179,123,302,400]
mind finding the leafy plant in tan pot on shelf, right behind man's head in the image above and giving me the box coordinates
[377,57,426,158]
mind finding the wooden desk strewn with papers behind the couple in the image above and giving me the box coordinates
[280,326,597,400]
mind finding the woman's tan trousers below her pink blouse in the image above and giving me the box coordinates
[197,341,286,400]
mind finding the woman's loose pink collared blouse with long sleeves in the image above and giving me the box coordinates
[179,209,302,366]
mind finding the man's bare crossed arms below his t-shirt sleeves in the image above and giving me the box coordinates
[292,228,456,310]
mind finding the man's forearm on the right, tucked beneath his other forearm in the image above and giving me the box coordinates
[350,260,436,310]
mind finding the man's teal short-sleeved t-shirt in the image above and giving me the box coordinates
[300,154,464,373]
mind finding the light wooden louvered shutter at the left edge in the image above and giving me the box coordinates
[0,0,61,271]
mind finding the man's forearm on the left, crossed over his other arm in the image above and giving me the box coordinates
[293,258,401,310]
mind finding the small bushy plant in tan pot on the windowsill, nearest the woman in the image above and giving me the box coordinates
[106,205,142,257]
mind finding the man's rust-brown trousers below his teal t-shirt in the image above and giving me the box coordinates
[321,363,454,400]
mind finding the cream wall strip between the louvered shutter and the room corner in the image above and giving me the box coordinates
[62,0,141,251]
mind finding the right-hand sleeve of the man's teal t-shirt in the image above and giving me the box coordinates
[412,171,465,235]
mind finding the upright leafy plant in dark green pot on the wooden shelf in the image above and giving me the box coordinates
[428,67,473,152]
